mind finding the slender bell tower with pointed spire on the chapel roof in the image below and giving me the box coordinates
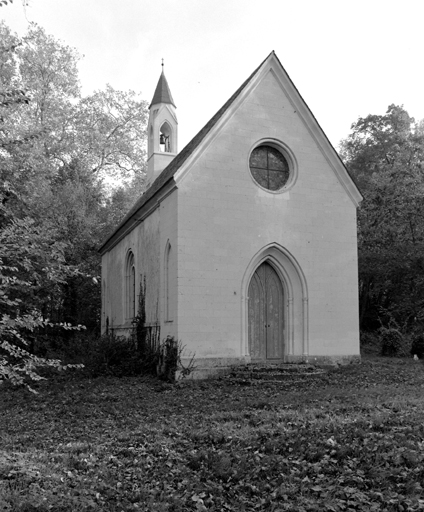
[147,59,178,186]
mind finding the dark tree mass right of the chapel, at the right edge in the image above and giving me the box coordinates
[342,105,424,329]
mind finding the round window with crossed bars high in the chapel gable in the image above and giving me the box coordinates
[249,145,290,191]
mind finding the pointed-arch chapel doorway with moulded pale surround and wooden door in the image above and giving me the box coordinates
[240,243,309,362]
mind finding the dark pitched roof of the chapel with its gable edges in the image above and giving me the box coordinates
[99,51,362,252]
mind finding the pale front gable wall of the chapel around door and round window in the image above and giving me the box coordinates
[174,68,359,358]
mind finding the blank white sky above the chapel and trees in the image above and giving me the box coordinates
[0,0,424,150]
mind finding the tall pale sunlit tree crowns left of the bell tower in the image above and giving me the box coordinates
[0,24,147,206]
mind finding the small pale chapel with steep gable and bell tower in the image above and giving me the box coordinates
[100,52,362,376]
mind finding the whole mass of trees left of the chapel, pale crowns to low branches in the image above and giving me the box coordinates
[0,23,147,388]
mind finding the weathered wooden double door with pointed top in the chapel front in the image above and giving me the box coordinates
[248,262,284,360]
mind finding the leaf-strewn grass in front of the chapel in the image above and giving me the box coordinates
[0,358,424,512]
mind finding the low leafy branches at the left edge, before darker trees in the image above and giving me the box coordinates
[0,208,85,389]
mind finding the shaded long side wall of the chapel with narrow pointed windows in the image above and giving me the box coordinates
[102,191,178,339]
